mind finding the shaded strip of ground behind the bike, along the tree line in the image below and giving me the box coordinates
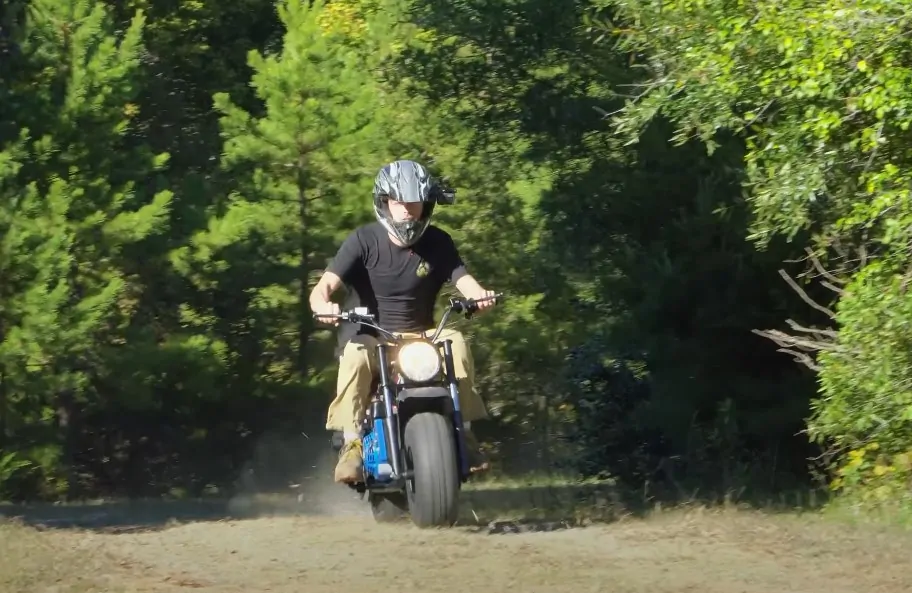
[0,440,819,534]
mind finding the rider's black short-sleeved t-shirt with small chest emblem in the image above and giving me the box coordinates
[326,222,465,345]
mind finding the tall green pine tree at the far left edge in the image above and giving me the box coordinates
[0,0,171,491]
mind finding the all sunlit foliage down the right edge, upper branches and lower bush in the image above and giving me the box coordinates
[608,0,912,502]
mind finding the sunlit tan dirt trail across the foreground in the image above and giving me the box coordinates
[0,500,912,593]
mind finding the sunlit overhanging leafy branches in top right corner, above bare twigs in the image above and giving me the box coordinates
[604,0,912,247]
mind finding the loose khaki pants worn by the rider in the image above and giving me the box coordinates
[326,329,488,434]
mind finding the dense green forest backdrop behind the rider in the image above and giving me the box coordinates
[0,0,912,520]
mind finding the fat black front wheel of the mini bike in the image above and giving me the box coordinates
[403,412,459,527]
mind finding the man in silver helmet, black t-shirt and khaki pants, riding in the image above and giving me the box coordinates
[310,161,495,518]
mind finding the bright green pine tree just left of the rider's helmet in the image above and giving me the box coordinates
[174,0,413,381]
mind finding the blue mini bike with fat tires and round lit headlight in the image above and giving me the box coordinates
[318,294,502,526]
